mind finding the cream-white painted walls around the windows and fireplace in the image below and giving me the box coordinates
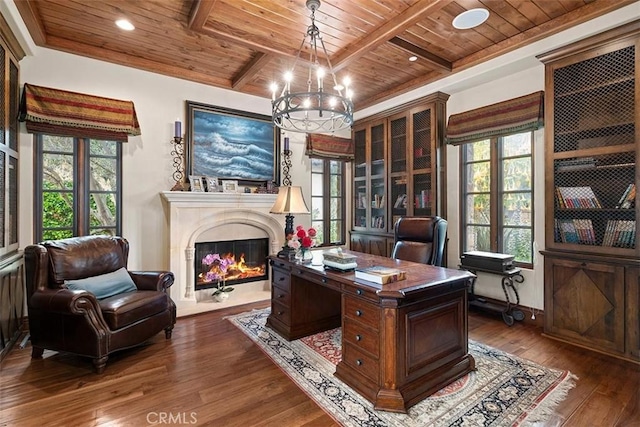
[5,1,640,308]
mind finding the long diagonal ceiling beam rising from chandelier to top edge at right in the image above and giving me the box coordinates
[331,0,454,71]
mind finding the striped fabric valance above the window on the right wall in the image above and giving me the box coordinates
[447,91,544,145]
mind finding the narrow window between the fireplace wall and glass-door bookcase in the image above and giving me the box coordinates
[311,158,345,245]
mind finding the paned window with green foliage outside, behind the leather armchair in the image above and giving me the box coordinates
[35,134,122,241]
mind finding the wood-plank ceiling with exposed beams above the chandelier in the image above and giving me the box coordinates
[14,0,635,110]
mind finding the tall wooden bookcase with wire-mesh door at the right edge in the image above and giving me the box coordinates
[539,23,640,361]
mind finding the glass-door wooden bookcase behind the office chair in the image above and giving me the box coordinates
[351,92,449,256]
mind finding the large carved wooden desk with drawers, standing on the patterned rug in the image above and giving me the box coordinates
[267,251,475,412]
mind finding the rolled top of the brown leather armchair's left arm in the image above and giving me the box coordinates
[29,289,101,314]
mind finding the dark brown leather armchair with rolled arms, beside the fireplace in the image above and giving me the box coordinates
[25,236,176,373]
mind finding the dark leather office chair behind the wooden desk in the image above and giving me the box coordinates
[391,216,447,267]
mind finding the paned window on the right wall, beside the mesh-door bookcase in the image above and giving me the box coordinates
[460,132,533,267]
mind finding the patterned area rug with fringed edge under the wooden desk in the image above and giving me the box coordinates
[228,308,576,427]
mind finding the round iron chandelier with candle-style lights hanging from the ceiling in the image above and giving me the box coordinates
[271,0,353,133]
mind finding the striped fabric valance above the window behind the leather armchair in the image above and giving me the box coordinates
[19,83,140,142]
